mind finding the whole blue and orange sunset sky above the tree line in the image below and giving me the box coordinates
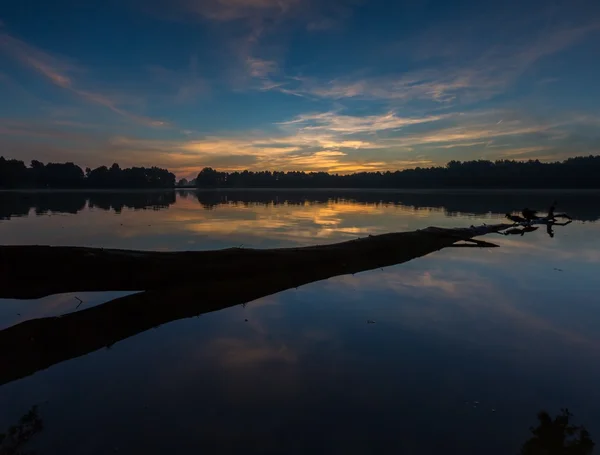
[0,0,600,178]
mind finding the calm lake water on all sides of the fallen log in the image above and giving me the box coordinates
[0,191,600,455]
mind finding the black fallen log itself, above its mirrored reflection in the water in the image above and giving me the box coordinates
[0,224,510,299]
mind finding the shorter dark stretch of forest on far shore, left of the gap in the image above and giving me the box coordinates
[0,156,175,189]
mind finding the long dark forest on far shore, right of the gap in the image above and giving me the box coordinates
[196,155,600,188]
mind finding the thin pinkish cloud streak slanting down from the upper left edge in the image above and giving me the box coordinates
[0,33,167,127]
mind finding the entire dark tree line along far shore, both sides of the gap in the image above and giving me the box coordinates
[0,155,600,189]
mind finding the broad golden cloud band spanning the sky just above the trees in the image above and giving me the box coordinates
[0,104,590,177]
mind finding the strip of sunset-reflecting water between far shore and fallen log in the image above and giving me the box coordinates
[0,190,600,250]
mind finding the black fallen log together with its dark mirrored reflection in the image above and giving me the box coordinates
[0,224,512,385]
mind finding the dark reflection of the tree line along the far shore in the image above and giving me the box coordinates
[0,190,600,221]
